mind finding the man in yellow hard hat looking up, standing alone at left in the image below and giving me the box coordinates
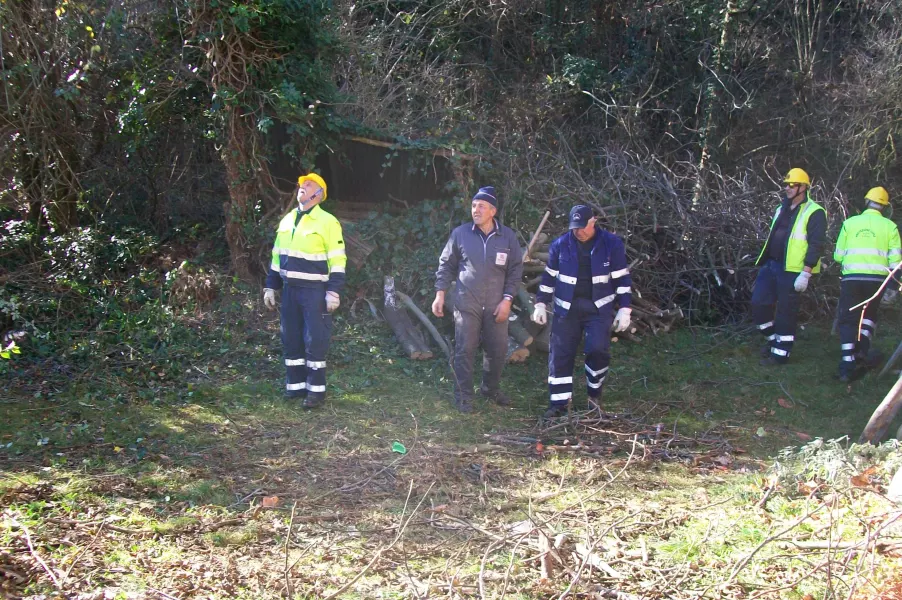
[263,173,347,408]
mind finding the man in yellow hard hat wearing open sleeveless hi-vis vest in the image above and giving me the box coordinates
[752,168,827,366]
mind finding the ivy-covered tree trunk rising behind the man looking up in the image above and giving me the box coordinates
[186,0,337,280]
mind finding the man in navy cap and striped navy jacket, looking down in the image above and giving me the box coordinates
[532,204,632,419]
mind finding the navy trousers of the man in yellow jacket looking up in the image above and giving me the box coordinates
[282,284,332,399]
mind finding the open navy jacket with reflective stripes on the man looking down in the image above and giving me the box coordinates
[536,227,632,316]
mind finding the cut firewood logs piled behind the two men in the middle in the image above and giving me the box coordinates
[383,220,683,363]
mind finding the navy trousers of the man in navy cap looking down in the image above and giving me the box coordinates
[548,298,614,406]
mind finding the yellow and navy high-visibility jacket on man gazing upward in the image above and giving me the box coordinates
[266,205,347,293]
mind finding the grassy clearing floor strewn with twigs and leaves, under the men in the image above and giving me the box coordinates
[0,307,902,599]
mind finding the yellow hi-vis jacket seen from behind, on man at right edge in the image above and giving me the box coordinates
[833,208,902,280]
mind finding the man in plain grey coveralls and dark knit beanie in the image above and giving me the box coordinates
[432,186,523,412]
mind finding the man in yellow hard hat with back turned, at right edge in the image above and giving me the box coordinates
[833,187,902,383]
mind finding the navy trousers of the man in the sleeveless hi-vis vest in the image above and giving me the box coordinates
[752,260,799,362]
